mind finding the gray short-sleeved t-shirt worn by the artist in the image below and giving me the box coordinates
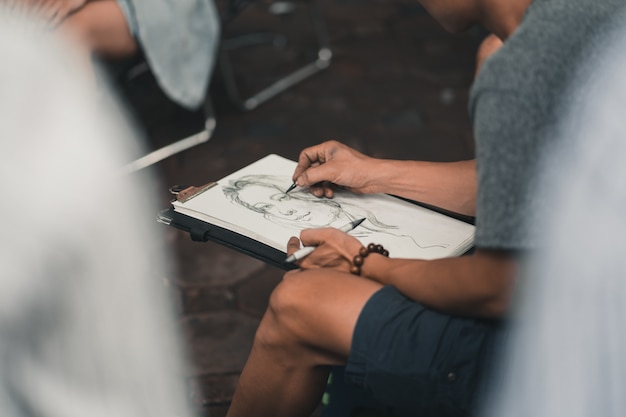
[470,0,624,250]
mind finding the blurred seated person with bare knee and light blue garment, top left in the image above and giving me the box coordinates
[0,0,220,109]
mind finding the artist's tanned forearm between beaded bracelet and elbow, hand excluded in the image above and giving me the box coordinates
[361,251,517,318]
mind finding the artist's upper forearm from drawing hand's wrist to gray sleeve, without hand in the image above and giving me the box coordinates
[368,159,476,216]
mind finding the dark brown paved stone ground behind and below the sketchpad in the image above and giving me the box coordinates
[114,0,481,417]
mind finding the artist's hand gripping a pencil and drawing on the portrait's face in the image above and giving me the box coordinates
[293,141,377,198]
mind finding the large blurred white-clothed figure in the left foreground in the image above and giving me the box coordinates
[0,10,199,417]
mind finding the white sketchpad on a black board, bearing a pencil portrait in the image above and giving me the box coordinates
[159,154,475,269]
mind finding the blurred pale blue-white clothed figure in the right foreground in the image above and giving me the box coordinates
[483,13,626,417]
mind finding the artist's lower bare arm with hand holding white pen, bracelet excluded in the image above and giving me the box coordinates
[287,228,517,318]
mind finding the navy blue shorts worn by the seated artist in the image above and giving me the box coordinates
[345,286,501,417]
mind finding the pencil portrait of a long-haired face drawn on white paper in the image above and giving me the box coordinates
[222,174,450,249]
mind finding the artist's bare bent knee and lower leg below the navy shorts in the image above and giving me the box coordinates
[227,270,381,417]
